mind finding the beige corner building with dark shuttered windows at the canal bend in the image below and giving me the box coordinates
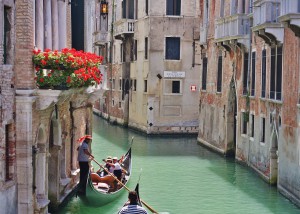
[94,0,200,134]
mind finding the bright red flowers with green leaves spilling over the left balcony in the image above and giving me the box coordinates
[32,48,103,90]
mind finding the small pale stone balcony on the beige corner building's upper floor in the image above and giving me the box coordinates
[114,19,135,40]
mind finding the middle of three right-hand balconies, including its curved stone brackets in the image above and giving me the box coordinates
[252,0,284,45]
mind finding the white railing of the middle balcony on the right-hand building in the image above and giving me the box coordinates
[253,0,280,27]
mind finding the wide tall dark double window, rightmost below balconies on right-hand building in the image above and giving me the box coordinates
[270,47,282,100]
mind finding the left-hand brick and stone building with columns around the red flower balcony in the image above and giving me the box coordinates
[0,0,98,213]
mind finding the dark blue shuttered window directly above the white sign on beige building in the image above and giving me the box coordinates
[165,37,180,60]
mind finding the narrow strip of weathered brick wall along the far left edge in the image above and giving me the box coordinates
[0,0,17,213]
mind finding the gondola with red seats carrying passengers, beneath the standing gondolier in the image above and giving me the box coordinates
[85,147,132,206]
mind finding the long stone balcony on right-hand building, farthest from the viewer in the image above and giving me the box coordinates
[215,14,250,47]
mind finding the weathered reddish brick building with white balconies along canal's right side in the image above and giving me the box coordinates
[198,0,300,206]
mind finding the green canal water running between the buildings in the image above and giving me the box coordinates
[58,116,300,214]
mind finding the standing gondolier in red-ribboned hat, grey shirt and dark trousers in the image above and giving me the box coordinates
[77,135,94,195]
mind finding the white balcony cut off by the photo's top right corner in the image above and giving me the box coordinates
[279,0,300,37]
